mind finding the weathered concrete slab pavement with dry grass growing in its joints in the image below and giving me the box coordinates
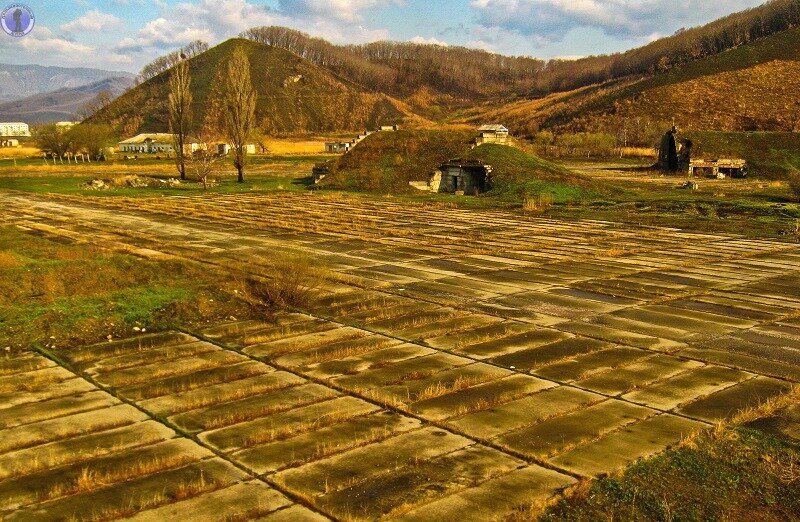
[0,193,800,520]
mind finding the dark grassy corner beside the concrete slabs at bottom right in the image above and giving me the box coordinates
[536,391,800,522]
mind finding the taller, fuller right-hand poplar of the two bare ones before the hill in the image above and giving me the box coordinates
[224,47,256,183]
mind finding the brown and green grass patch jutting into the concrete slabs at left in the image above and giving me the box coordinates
[0,227,253,349]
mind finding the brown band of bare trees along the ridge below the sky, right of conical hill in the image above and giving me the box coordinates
[241,0,800,98]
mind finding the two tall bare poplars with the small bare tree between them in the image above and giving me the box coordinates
[169,47,256,187]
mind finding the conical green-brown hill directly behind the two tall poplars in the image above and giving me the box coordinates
[90,39,414,136]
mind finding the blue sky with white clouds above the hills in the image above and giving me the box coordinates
[0,0,763,73]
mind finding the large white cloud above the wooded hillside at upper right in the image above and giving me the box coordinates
[471,0,762,41]
